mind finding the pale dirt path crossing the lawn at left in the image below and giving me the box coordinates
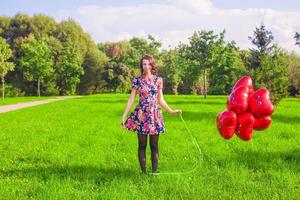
[0,96,81,113]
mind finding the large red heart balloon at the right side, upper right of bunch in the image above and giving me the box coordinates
[249,88,274,118]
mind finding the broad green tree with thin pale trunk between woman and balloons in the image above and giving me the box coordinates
[180,31,245,97]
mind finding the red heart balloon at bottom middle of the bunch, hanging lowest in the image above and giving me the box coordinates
[235,112,255,141]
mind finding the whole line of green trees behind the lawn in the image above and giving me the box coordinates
[0,13,300,103]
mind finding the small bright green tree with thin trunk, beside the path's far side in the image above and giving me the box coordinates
[21,38,53,96]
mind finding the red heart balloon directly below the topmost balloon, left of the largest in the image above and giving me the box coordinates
[227,85,249,114]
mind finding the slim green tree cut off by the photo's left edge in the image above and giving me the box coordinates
[0,37,14,100]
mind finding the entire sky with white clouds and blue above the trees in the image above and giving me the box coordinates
[0,0,300,53]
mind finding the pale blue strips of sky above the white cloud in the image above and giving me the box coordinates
[0,0,300,16]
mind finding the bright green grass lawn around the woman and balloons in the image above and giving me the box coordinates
[0,94,300,199]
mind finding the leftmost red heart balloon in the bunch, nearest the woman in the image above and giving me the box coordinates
[216,110,237,139]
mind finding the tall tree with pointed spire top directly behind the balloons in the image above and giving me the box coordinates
[247,24,288,104]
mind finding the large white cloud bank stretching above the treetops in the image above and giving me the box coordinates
[57,0,300,52]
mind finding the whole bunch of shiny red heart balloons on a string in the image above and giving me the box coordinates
[216,76,274,141]
